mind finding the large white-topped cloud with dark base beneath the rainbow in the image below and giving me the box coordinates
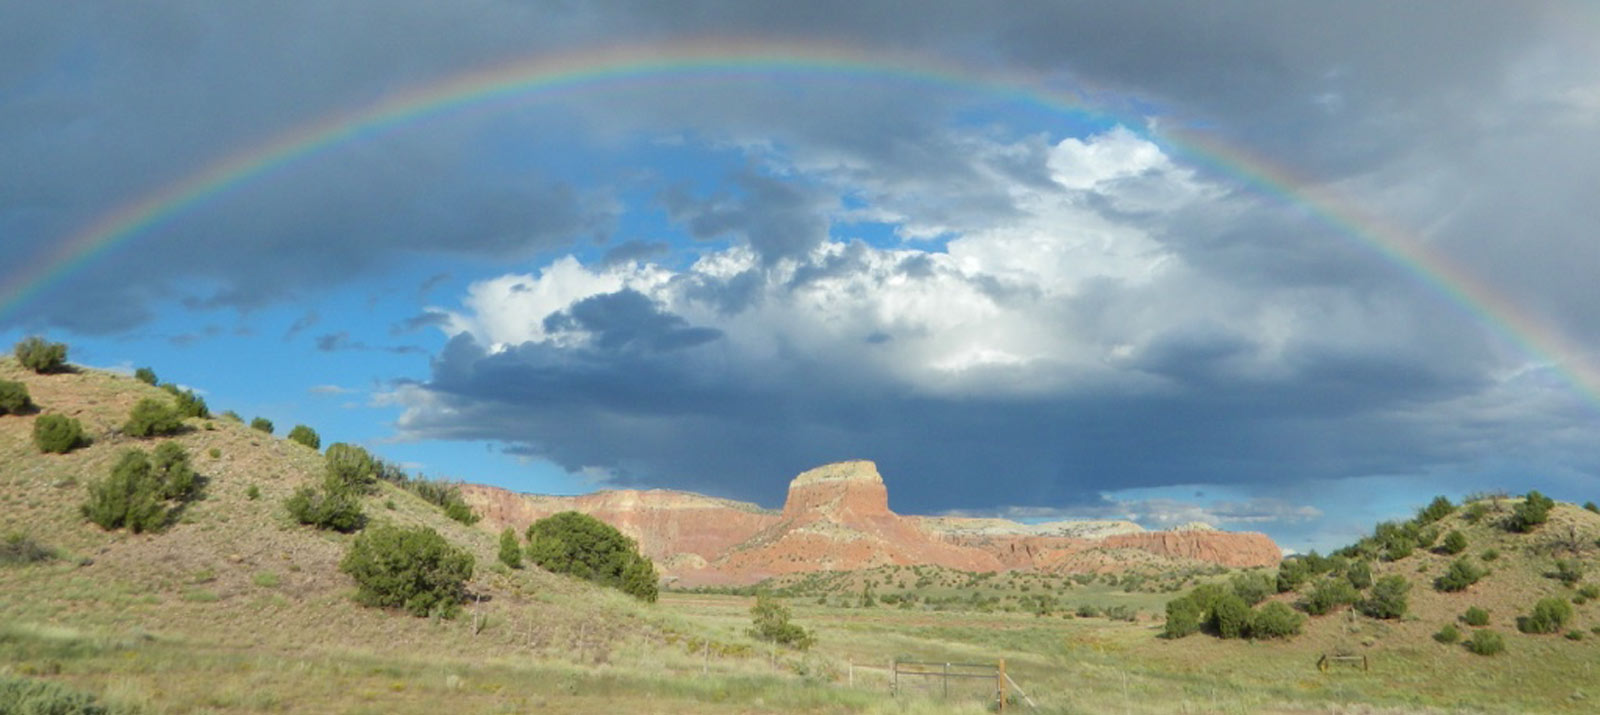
[389,131,1597,508]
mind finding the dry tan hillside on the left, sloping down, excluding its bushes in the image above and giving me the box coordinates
[0,357,723,712]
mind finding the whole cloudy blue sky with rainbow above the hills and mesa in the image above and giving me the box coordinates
[0,0,1600,552]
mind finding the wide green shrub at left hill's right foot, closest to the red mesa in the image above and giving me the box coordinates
[528,512,658,603]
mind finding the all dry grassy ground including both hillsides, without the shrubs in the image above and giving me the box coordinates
[0,360,1600,715]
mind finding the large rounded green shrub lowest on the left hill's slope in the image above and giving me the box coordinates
[339,525,474,616]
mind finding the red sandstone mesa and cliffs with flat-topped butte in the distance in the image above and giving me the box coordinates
[461,461,1280,585]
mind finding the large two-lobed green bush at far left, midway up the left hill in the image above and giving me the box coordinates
[82,441,200,534]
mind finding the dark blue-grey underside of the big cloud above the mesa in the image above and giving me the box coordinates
[402,318,1523,513]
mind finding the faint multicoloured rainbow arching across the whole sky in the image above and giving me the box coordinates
[0,38,1600,406]
